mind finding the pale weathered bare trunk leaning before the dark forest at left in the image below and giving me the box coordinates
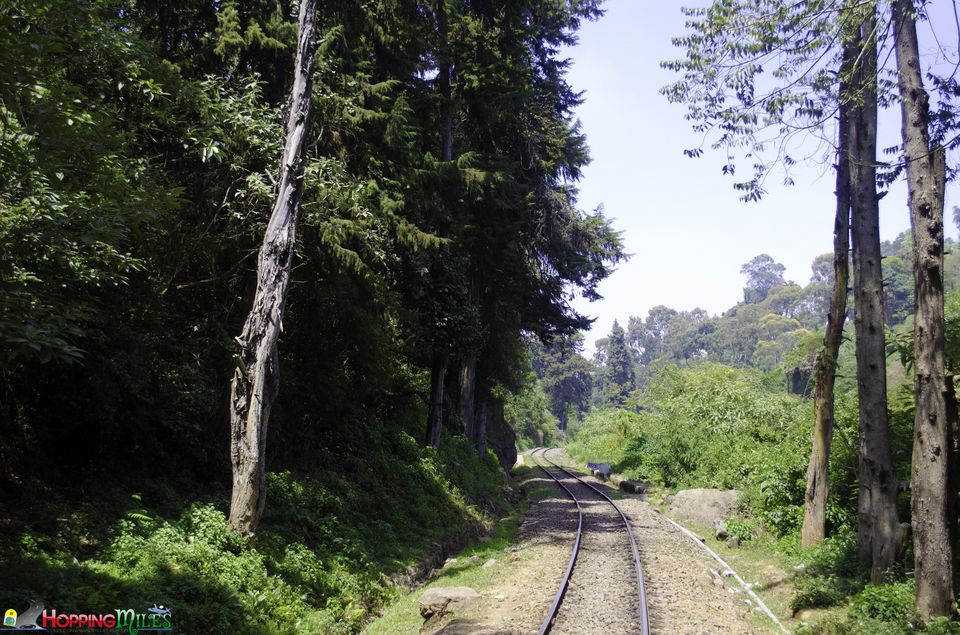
[229,0,317,535]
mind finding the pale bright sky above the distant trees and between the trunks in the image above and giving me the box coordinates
[567,0,958,356]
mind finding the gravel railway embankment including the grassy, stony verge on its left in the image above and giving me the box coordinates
[366,451,776,635]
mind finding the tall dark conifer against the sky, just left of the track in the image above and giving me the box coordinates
[410,1,625,452]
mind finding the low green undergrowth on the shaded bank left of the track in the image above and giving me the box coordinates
[0,432,508,634]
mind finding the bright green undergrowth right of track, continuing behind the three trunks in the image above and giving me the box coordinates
[566,363,960,635]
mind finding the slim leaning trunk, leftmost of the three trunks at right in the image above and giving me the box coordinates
[801,71,855,547]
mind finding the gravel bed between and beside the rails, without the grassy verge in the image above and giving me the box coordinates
[438,454,775,635]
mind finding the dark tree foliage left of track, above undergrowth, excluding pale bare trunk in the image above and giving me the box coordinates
[0,0,625,496]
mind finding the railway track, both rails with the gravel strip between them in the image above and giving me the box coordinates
[530,448,650,635]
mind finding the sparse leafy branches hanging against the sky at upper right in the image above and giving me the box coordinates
[661,0,858,201]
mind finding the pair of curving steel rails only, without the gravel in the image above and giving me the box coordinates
[530,448,650,635]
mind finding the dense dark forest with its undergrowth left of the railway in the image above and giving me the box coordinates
[0,0,624,633]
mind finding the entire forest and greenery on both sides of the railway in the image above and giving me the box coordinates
[0,0,960,633]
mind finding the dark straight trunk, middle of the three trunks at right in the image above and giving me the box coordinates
[850,4,900,582]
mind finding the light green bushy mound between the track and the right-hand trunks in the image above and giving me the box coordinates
[568,363,812,535]
